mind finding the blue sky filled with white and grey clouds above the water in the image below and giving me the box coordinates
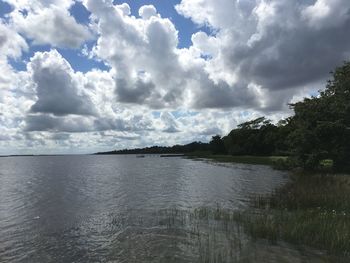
[0,0,350,155]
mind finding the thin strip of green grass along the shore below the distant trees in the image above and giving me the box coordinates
[186,152,287,165]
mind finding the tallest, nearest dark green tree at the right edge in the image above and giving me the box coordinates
[289,62,350,170]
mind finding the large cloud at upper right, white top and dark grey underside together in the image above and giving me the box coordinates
[217,0,350,98]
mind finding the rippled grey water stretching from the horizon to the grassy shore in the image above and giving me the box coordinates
[0,156,334,262]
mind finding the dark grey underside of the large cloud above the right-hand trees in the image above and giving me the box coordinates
[234,18,350,90]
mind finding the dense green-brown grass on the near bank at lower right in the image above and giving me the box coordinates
[237,174,350,256]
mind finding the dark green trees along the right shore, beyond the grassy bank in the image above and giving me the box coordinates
[210,62,350,170]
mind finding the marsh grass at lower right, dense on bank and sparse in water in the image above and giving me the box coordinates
[156,174,350,262]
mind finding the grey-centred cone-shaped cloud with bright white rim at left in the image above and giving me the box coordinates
[30,50,95,116]
